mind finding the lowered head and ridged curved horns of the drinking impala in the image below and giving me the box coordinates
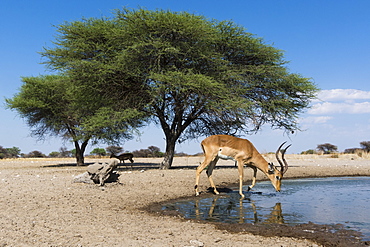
[267,142,290,192]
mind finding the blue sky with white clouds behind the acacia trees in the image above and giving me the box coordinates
[0,0,370,154]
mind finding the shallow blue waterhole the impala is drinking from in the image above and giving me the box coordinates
[163,177,370,240]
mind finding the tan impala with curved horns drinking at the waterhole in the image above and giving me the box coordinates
[195,135,290,197]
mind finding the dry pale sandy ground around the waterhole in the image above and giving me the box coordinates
[0,155,370,247]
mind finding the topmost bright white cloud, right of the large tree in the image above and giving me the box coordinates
[317,89,370,101]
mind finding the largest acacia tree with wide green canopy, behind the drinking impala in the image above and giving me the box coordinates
[34,9,317,168]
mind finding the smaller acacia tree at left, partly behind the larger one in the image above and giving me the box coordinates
[6,75,142,165]
